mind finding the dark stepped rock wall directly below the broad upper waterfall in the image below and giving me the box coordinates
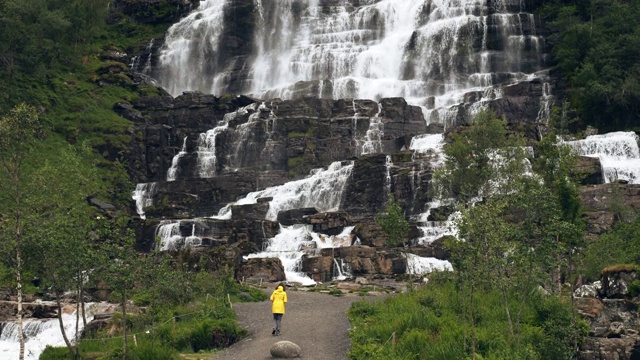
[124,93,426,186]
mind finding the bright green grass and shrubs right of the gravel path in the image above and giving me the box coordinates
[348,274,584,360]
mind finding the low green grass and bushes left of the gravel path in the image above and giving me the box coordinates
[40,268,266,360]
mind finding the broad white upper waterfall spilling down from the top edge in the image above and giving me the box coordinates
[153,0,550,124]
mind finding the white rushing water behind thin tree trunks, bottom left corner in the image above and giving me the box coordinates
[0,304,93,360]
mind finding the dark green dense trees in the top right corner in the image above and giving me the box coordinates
[530,0,640,131]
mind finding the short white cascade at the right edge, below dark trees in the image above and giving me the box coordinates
[566,131,640,184]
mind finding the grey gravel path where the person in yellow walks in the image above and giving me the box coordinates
[214,290,368,360]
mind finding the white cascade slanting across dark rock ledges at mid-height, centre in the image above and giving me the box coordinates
[216,162,353,221]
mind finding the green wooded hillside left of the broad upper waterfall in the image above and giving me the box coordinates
[0,0,178,211]
